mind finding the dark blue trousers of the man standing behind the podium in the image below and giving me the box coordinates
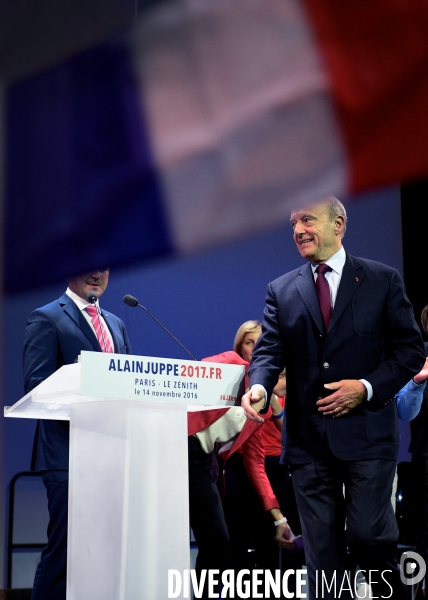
[31,471,68,600]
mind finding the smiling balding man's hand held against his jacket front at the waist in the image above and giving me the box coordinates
[317,379,367,417]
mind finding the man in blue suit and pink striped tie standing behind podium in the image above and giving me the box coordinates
[23,269,131,600]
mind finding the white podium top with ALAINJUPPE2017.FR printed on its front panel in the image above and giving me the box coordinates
[4,352,245,421]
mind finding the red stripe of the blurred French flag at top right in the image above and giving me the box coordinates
[303,0,428,191]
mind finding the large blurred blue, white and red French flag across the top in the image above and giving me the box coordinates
[5,0,428,292]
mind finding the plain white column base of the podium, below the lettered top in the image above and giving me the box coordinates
[67,400,190,600]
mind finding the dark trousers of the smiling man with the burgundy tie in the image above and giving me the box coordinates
[293,449,408,599]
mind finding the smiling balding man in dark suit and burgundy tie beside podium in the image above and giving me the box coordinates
[242,197,425,599]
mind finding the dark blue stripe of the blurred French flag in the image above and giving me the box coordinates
[5,43,172,292]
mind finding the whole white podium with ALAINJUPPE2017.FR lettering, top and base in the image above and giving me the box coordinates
[5,352,244,600]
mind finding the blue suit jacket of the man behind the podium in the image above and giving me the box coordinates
[23,294,131,470]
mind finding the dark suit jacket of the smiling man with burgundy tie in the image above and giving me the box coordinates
[250,254,425,463]
